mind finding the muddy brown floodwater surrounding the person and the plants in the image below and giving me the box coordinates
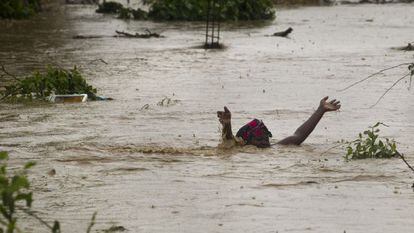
[0,4,414,233]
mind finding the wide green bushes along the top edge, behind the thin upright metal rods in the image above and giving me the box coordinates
[96,0,275,21]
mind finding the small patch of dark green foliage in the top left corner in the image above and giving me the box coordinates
[0,0,41,19]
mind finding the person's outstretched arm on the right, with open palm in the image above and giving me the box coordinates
[278,96,341,145]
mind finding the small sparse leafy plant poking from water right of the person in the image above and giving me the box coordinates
[345,122,399,160]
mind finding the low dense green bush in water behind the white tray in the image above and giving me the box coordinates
[1,66,96,100]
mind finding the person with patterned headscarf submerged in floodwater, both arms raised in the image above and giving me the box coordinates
[217,96,341,148]
